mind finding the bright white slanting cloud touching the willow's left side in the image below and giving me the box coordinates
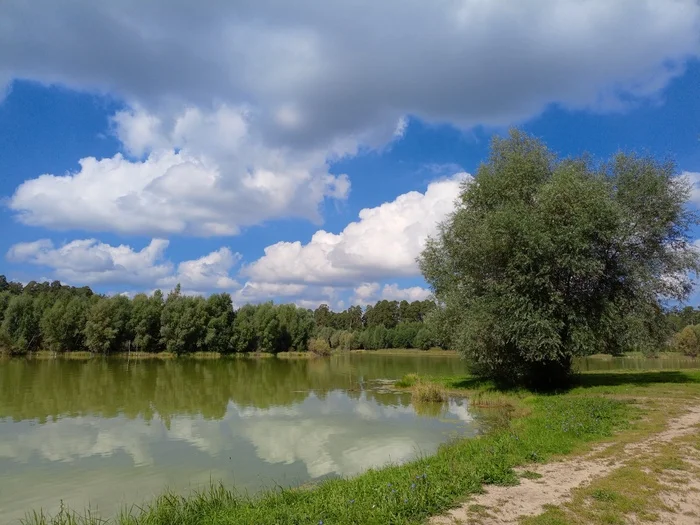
[242,173,469,285]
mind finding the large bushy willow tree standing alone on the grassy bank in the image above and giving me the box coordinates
[419,131,698,387]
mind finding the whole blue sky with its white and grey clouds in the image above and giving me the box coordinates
[0,0,700,309]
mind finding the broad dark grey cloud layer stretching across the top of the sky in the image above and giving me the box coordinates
[0,0,700,141]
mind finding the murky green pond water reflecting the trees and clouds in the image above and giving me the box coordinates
[0,354,470,523]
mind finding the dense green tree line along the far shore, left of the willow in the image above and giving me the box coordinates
[0,276,438,354]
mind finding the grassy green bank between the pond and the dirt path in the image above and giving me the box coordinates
[32,371,700,525]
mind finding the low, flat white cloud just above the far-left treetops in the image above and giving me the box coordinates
[7,239,240,293]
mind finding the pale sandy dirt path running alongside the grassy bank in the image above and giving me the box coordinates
[429,405,700,525]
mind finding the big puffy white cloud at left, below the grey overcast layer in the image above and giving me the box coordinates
[10,106,350,236]
